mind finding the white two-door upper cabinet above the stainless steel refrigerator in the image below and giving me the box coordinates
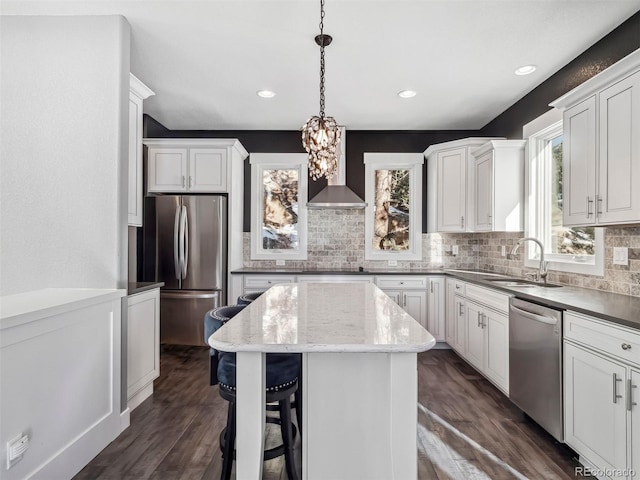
[144,138,247,193]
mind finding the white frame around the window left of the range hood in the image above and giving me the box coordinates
[249,153,308,260]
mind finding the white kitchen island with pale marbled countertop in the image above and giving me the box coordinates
[209,283,435,480]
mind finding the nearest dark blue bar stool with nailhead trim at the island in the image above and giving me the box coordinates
[205,305,300,480]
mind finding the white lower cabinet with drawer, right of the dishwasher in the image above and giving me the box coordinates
[564,312,640,479]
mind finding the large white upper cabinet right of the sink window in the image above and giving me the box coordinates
[551,50,640,225]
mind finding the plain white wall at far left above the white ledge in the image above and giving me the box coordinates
[0,16,130,295]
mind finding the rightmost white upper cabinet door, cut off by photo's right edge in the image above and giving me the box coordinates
[596,72,640,223]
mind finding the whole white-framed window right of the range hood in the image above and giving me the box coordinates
[364,153,424,260]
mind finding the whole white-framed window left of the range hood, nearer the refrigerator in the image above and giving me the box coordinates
[249,153,307,260]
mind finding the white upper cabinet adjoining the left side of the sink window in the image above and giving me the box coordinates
[468,140,526,232]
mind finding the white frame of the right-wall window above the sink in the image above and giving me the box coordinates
[523,109,604,276]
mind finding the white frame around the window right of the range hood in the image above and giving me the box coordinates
[363,152,424,261]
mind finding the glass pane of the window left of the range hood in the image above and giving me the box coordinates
[262,170,298,250]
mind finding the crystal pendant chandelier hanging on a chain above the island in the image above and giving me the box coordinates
[301,0,340,180]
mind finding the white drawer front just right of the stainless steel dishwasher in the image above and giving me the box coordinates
[564,312,640,365]
